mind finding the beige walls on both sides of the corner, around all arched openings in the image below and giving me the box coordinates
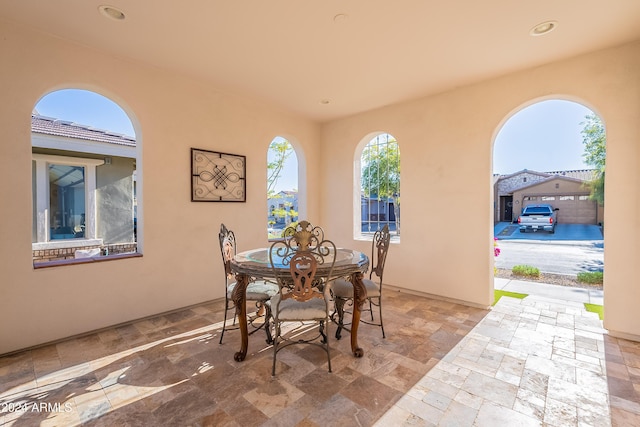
[0,18,640,354]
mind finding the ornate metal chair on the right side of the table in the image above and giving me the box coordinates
[331,225,391,339]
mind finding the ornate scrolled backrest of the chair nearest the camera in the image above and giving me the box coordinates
[269,221,336,302]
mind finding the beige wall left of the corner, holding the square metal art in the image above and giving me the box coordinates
[0,22,320,354]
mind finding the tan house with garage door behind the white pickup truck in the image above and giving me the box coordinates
[494,169,604,224]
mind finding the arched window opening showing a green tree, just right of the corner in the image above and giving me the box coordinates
[356,133,400,237]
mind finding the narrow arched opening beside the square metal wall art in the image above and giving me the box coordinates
[267,136,298,239]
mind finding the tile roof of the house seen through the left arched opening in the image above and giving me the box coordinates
[31,114,136,147]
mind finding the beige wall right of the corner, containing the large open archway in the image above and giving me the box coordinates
[322,42,640,337]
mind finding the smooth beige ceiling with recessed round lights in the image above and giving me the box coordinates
[0,0,640,122]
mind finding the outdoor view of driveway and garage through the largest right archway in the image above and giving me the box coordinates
[492,99,606,286]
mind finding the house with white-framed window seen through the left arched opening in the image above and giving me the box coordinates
[31,113,136,262]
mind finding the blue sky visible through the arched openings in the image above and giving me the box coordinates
[36,89,591,191]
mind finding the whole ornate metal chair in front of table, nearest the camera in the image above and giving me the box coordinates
[269,221,336,376]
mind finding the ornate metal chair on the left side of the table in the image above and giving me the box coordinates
[218,224,278,344]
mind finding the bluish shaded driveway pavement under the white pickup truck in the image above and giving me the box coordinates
[494,222,603,241]
